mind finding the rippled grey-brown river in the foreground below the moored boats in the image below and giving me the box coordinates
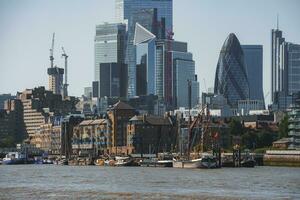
[0,165,300,200]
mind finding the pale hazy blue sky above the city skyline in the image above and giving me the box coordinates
[0,0,300,103]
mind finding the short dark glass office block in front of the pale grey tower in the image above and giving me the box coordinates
[100,63,127,97]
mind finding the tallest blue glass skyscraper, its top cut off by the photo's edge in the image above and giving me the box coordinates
[115,0,173,96]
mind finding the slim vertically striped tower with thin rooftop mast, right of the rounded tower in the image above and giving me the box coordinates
[271,27,285,103]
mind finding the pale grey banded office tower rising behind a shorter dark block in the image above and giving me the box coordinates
[95,23,126,95]
